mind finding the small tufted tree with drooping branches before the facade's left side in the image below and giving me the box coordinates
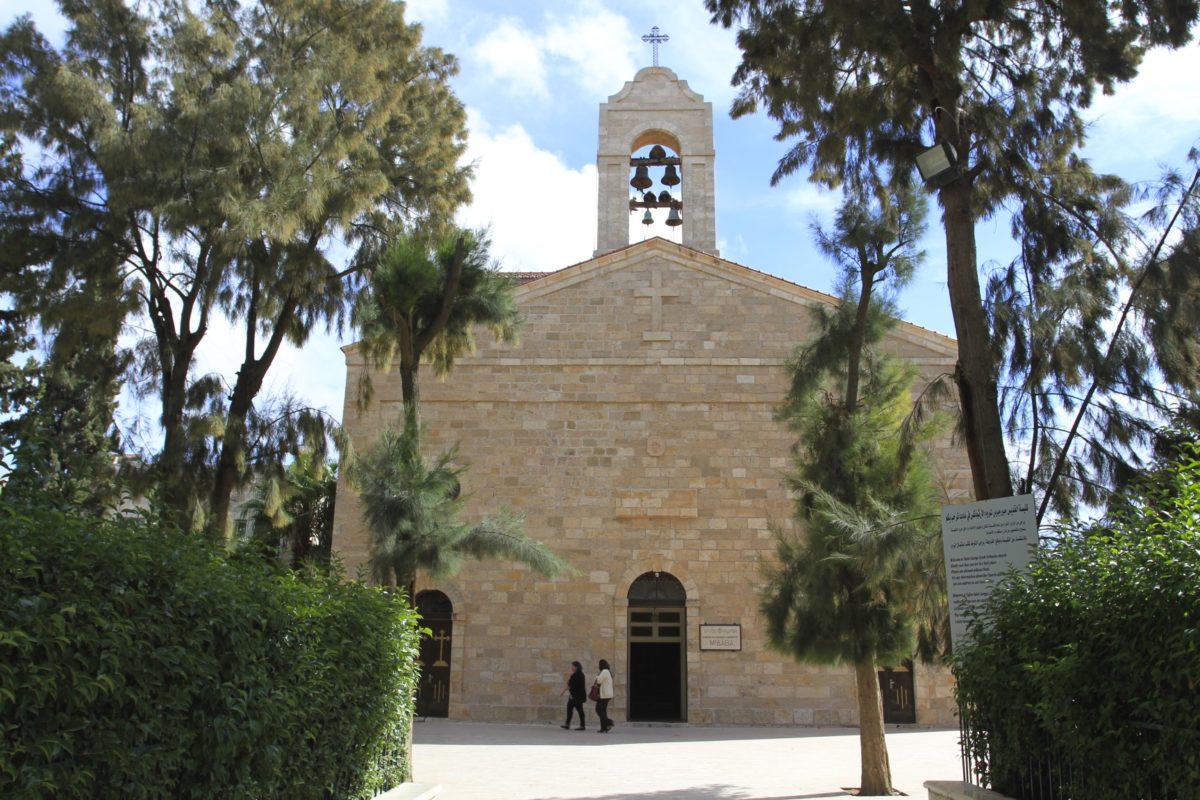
[354,230,569,595]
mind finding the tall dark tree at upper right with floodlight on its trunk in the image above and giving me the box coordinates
[706,0,1200,499]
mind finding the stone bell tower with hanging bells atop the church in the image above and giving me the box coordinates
[595,65,719,255]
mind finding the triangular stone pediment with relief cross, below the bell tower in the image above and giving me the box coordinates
[346,237,958,368]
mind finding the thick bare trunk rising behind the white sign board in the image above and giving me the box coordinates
[942,178,1013,500]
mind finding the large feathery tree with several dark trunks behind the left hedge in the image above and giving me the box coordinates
[0,0,469,537]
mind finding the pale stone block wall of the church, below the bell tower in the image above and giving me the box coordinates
[334,240,968,726]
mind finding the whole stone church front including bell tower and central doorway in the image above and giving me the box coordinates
[334,67,970,726]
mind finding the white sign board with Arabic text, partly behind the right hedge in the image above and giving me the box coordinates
[942,494,1038,646]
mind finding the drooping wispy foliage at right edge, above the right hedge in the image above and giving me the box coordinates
[986,165,1200,523]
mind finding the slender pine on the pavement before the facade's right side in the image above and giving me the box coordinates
[761,192,941,795]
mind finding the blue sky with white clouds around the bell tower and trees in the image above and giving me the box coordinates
[9,0,1200,438]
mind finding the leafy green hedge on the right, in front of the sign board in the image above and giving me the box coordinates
[954,459,1200,800]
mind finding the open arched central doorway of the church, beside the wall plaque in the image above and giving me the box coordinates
[629,572,688,722]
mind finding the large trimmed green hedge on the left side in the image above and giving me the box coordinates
[0,503,418,800]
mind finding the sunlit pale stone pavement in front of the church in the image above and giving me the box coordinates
[413,715,962,800]
